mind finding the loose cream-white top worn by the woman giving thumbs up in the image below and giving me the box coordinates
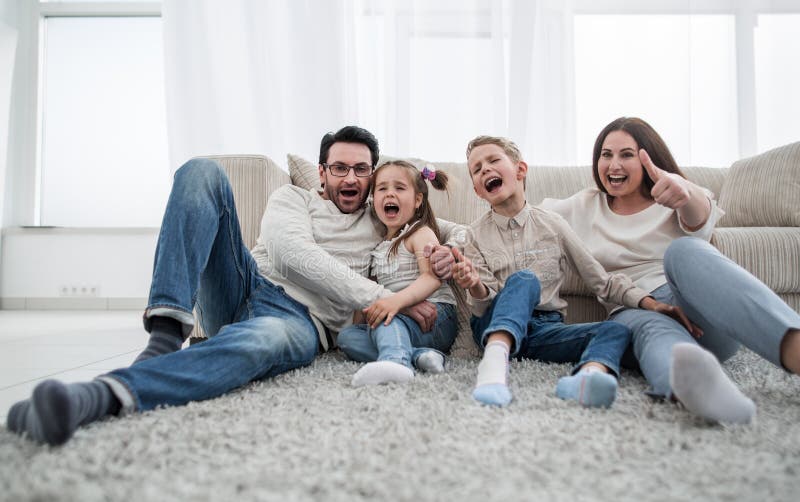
[541,188,725,292]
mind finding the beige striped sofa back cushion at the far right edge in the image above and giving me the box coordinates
[719,142,800,227]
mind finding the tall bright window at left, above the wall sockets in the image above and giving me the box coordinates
[38,3,170,227]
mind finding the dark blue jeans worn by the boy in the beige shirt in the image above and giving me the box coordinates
[470,270,631,376]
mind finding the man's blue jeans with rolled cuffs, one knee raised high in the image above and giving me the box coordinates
[100,159,318,411]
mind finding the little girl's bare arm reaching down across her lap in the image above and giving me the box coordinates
[364,227,442,328]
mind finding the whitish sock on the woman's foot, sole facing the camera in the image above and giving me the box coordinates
[669,343,756,424]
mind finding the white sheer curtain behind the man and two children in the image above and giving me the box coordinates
[162,0,575,169]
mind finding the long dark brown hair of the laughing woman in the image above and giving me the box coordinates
[592,117,686,196]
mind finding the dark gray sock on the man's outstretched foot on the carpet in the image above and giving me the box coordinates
[6,380,120,446]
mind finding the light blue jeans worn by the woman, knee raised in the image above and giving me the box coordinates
[611,237,800,396]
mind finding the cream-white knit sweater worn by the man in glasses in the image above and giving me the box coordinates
[253,185,391,349]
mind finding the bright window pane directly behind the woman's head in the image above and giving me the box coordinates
[575,14,739,166]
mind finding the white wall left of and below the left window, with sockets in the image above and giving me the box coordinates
[0,0,158,308]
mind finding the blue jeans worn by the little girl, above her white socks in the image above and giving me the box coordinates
[336,303,458,369]
